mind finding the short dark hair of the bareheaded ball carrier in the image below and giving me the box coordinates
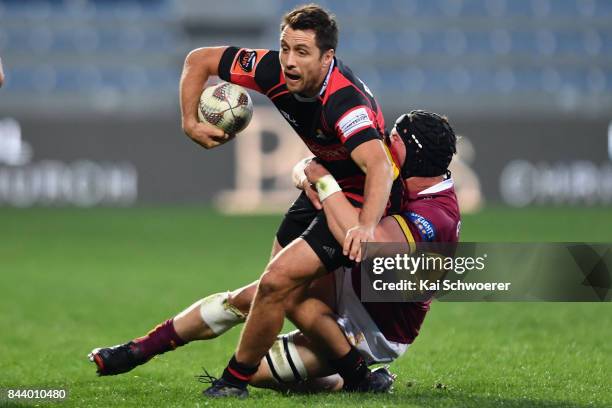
[281,3,338,53]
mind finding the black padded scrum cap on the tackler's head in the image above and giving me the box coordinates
[395,110,457,178]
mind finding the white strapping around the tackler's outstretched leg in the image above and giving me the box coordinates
[200,292,246,336]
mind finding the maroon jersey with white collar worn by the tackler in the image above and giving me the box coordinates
[352,179,461,344]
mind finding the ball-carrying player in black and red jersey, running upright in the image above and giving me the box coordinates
[180,5,398,396]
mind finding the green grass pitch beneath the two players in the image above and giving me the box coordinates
[0,207,612,408]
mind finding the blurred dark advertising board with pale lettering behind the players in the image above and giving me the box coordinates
[0,110,612,209]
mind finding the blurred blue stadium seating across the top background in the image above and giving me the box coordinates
[0,0,612,113]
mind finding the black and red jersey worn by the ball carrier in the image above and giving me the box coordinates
[219,47,398,202]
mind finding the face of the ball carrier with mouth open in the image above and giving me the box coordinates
[280,27,334,96]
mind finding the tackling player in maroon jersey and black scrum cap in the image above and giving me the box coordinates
[91,111,460,391]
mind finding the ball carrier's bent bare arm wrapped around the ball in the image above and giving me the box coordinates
[180,47,227,135]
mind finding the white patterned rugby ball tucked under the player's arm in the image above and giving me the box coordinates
[198,82,253,135]
